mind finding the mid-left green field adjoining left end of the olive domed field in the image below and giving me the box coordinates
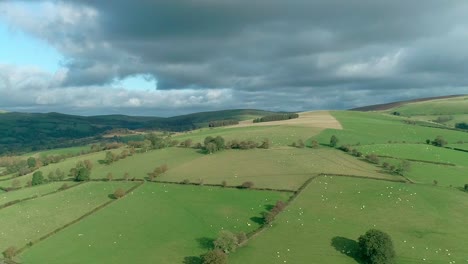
[91,147,204,179]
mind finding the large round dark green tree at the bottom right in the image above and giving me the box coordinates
[358,229,395,264]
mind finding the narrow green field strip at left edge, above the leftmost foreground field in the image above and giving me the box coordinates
[0,182,76,206]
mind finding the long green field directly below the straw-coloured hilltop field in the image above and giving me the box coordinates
[174,125,323,146]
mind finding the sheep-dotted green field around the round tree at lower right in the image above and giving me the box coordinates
[229,177,468,264]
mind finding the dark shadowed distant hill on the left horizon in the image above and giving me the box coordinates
[0,109,274,154]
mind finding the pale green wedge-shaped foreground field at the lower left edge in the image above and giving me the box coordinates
[0,182,134,252]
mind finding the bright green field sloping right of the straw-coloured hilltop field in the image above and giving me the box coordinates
[314,111,467,145]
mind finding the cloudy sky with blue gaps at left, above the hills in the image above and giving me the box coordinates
[0,0,468,116]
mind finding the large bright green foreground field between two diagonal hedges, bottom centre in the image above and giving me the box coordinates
[20,183,287,264]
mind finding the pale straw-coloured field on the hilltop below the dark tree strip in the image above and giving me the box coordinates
[233,111,343,129]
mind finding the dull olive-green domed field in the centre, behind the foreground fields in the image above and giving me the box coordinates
[157,147,397,190]
